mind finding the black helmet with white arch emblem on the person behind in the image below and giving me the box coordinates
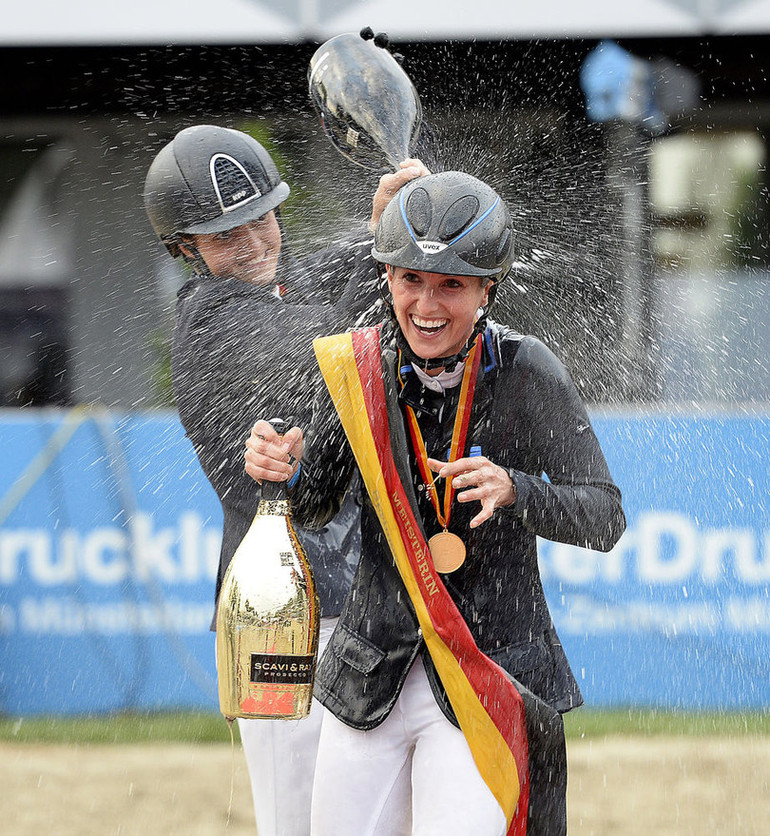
[144,125,289,257]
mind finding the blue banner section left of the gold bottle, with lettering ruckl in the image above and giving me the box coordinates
[0,410,221,715]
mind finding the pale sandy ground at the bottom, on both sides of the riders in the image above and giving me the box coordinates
[0,737,770,836]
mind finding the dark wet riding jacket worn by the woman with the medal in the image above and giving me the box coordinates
[292,323,625,729]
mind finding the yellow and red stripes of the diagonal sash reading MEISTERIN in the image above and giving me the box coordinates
[313,328,529,836]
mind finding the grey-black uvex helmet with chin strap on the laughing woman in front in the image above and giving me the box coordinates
[372,171,513,370]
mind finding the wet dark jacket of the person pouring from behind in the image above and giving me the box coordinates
[171,236,381,615]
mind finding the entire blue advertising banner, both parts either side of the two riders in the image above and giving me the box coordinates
[0,410,770,715]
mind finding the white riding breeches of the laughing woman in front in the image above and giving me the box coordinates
[310,658,507,836]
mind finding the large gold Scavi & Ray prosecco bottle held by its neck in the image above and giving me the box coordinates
[217,454,319,720]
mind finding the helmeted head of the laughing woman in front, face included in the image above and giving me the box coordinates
[372,171,513,372]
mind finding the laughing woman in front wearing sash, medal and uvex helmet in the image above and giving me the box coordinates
[246,171,625,836]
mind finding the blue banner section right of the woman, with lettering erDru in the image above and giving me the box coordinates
[539,414,770,709]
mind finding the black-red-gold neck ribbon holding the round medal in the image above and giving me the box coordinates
[399,334,481,531]
